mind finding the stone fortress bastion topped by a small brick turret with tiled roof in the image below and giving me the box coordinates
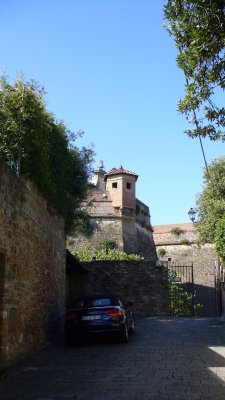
[68,163,156,261]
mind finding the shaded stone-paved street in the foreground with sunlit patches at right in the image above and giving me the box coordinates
[0,318,225,400]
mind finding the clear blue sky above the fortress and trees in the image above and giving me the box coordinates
[0,0,224,225]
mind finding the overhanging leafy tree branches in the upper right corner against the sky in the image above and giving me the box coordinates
[164,0,225,140]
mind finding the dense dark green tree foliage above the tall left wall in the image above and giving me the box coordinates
[0,77,93,232]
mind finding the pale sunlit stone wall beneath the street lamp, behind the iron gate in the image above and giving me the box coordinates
[154,224,220,317]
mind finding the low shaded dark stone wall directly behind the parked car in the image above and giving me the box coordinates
[67,261,168,316]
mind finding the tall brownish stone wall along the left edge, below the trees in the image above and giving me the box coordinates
[0,166,65,359]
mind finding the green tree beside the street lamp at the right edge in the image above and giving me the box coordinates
[196,157,225,243]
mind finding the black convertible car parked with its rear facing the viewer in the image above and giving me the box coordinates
[65,294,135,346]
